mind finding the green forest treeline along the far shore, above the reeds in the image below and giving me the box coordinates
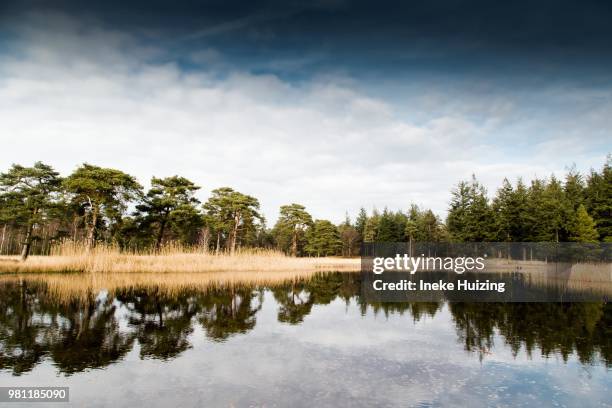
[0,156,612,259]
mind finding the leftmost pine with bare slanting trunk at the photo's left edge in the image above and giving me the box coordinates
[0,162,61,261]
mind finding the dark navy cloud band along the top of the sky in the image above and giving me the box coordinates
[4,0,612,80]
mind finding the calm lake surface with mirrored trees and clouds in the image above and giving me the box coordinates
[0,274,612,407]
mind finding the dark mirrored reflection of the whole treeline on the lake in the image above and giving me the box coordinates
[0,273,612,375]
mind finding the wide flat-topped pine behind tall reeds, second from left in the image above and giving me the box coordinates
[64,163,142,250]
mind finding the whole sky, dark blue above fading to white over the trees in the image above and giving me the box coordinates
[0,0,612,223]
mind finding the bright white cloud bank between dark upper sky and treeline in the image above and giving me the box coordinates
[0,15,605,221]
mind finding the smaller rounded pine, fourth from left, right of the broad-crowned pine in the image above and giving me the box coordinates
[204,187,264,254]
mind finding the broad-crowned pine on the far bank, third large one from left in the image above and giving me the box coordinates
[136,176,200,250]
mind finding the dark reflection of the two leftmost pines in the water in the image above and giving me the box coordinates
[0,280,132,375]
